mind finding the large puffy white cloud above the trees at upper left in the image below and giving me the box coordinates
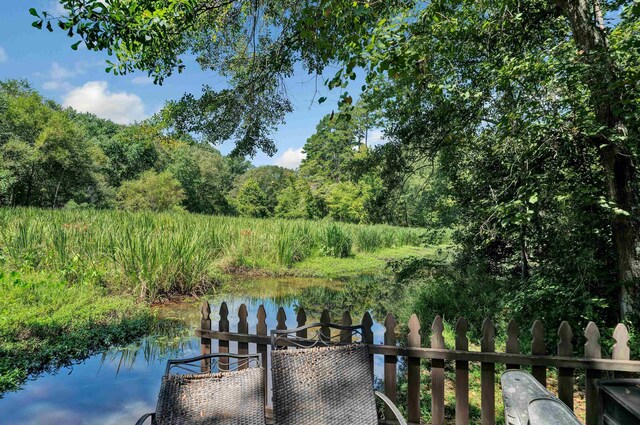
[62,81,146,124]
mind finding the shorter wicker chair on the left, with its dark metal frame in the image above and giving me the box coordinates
[136,353,265,425]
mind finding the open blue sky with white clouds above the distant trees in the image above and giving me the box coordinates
[0,0,379,168]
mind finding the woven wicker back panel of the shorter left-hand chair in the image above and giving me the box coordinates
[156,368,265,425]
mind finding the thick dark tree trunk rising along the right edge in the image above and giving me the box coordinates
[557,0,640,317]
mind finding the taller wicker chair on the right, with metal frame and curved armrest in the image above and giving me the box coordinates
[271,323,406,425]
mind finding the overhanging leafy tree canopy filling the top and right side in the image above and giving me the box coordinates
[32,0,640,316]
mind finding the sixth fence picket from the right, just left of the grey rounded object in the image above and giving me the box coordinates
[480,318,496,425]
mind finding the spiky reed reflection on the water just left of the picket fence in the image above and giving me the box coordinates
[101,318,194,375]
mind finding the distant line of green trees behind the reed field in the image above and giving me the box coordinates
[0,80,450,226]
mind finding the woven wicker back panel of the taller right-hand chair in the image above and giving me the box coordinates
[271,344,378,425]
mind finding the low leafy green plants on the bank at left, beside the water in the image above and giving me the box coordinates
[0,273,152,394]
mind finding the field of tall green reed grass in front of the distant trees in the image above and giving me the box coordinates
[0,208,427,299]
